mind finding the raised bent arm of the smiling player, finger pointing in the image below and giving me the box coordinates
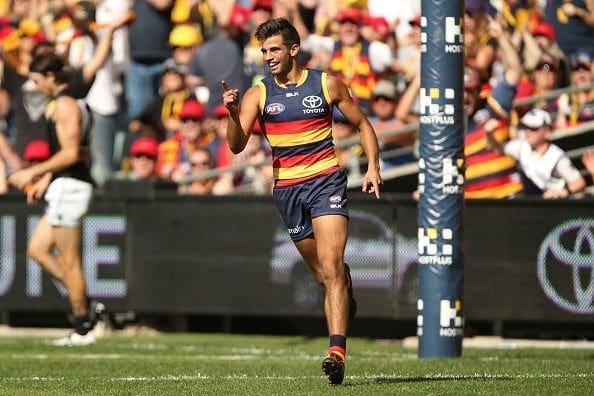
[221,81,260,154]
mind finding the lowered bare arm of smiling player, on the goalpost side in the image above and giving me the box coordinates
[328,76,383,198]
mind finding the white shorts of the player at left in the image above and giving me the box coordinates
[45,177,93,227]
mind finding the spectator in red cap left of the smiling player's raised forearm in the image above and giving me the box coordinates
[157,96,215,179]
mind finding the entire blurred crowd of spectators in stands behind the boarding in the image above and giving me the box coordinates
[0,0,594,198]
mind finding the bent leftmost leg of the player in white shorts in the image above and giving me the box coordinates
[27,215,64,283]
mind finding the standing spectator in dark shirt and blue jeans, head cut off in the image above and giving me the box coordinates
[125,0,174,120]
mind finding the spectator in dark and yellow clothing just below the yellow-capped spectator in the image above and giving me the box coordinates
[128,58,192,141]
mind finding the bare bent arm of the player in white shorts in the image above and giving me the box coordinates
[9,96,82,189]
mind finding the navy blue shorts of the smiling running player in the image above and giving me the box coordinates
[273,169,349,241]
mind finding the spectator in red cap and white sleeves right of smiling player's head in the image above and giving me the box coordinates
[295,7,403,113]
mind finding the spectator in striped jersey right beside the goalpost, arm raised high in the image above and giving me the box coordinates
[464,20,523,199]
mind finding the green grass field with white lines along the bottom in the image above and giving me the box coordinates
[0,333,594,395]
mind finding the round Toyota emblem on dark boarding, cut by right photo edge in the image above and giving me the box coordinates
[537,219,594,315]
